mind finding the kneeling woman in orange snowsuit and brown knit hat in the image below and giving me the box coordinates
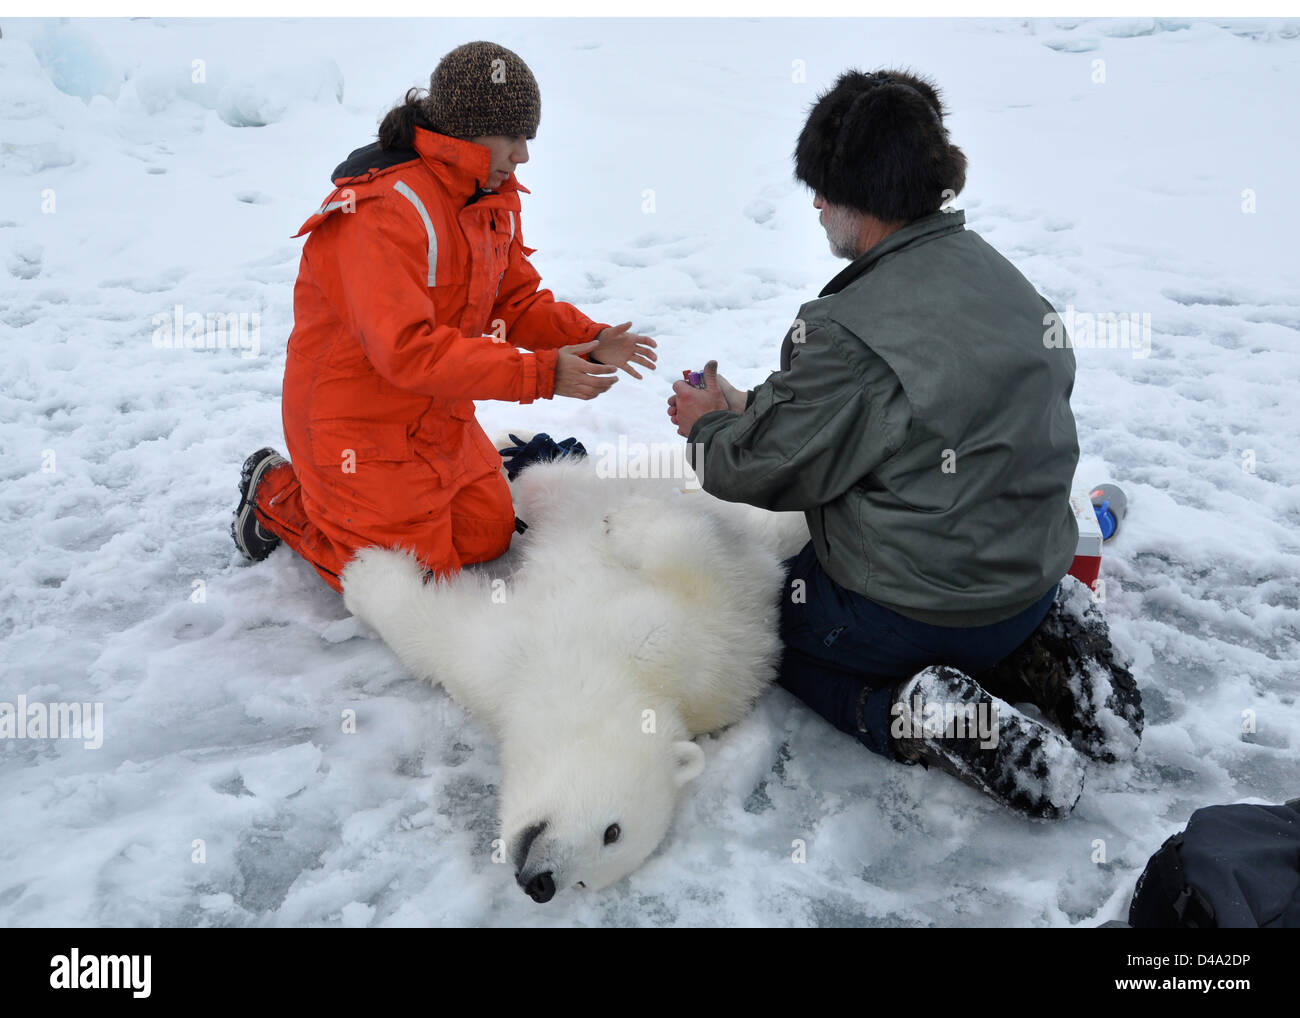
[231,42,655,590]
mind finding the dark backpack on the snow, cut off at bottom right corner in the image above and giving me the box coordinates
[1128,798,1300,930]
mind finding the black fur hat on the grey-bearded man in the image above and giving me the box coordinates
[794,70,966,222]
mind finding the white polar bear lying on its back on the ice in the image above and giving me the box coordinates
[342,458,807,900]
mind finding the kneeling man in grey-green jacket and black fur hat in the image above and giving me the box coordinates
[668,72,1141,816]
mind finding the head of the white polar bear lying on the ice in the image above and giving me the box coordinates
[501,725,705,901]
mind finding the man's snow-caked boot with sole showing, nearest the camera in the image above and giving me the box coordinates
[891,664,1083,820]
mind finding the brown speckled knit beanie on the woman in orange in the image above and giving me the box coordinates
[426,42,542,138]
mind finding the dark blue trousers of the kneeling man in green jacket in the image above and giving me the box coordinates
[776,542,1057,759]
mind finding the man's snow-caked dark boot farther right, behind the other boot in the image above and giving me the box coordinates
[979,576,1144,763]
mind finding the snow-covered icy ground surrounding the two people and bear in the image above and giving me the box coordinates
[0,20,1300,926]
